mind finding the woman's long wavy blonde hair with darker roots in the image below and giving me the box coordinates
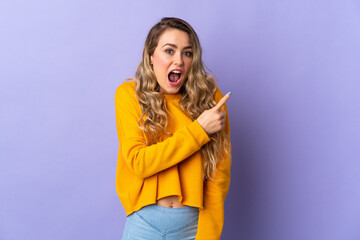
[128,18,231,180]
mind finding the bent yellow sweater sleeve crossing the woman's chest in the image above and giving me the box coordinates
[115,83,210,178]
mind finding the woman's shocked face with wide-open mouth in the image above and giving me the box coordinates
[150,29,192,94]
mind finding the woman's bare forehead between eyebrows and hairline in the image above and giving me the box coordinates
[158,28,191,47]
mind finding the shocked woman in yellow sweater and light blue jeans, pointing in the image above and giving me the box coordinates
[115,18,231,240]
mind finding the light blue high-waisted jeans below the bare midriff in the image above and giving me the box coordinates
[122,204,199,240]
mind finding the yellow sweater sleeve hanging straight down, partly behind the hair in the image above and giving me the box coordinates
[195,90,231,240]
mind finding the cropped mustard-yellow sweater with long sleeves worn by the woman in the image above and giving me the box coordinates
[115,81,231,240]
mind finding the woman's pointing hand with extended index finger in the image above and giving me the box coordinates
[197,92,231,135]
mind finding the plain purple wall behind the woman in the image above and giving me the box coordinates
[0,0,360,240]
